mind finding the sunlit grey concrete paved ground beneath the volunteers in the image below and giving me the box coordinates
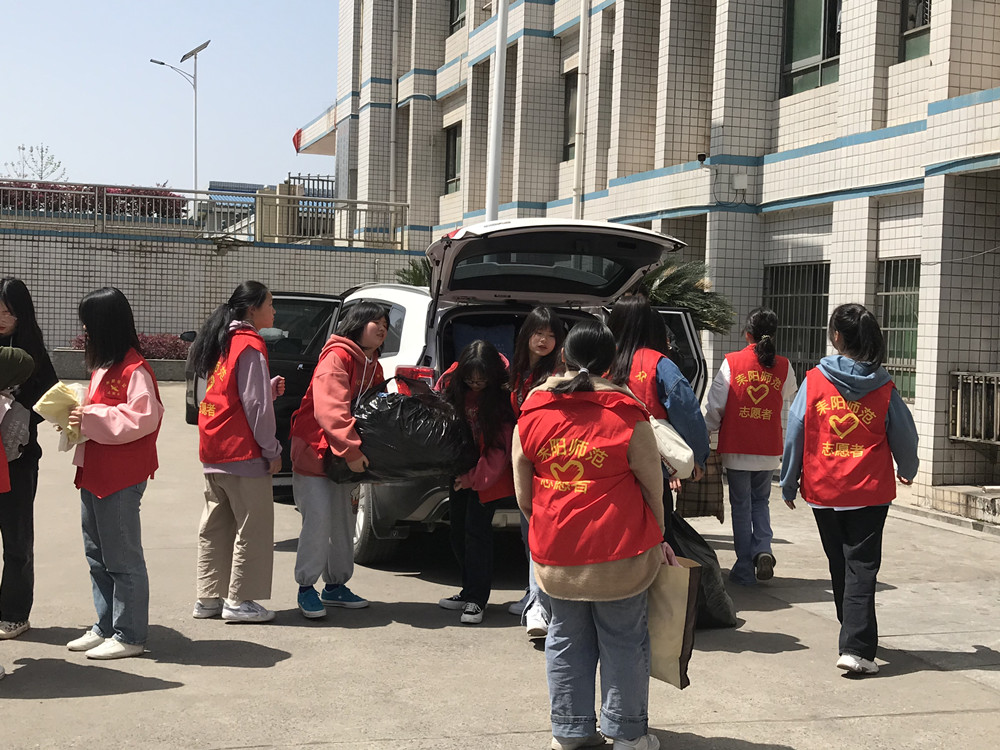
[0,384,1000,750]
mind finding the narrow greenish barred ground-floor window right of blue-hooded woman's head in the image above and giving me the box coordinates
[876,258,920,401]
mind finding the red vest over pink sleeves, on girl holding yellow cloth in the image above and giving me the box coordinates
[75,349,162,498]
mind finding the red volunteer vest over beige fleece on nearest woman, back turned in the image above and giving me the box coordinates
[517,391,663,566]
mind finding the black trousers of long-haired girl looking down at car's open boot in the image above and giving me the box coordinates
[448,489,495,608]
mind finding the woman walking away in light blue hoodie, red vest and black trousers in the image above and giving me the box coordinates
[781,304,919,675]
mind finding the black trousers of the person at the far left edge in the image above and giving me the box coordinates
[0,456,38,622]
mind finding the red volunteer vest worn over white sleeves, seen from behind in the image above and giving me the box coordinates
[719,345,788,456]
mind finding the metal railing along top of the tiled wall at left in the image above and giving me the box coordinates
[0,180,407,248]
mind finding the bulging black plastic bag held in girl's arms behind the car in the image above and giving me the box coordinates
[323,386,479,483]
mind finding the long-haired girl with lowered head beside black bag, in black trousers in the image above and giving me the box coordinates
[438,339,514,625]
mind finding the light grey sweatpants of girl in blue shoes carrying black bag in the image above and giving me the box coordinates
[292,473,358,586]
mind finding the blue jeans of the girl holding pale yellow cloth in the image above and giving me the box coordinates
[80,482,149,645]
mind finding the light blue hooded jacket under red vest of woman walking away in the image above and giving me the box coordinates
[781,354,919,500]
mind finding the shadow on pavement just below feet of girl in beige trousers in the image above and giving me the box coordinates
[146,622,291,669]
